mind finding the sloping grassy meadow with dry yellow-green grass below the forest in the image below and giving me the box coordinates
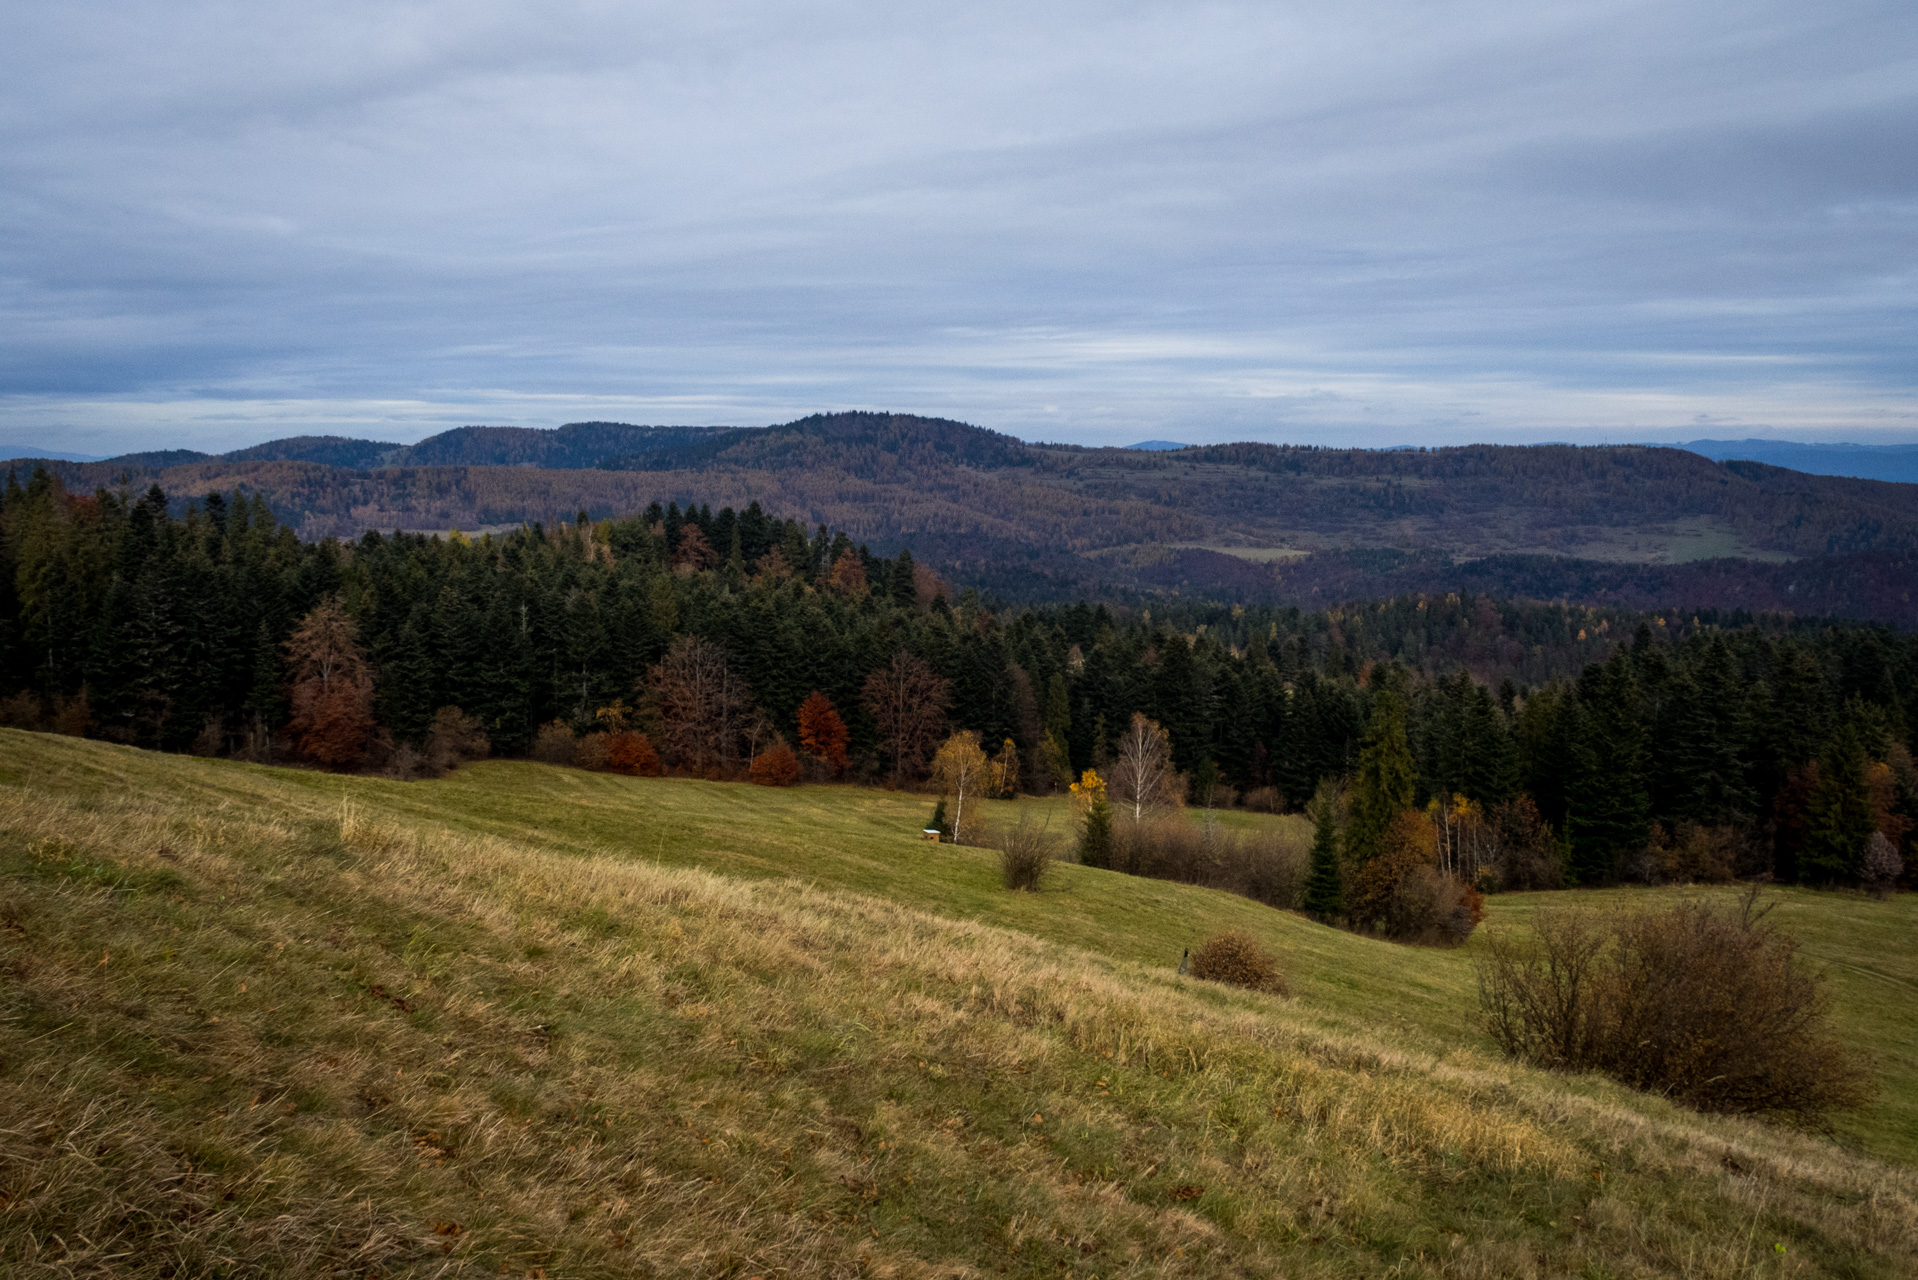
[0,731,1918,1278]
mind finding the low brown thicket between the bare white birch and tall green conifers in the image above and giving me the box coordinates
[1111,814,1310,910]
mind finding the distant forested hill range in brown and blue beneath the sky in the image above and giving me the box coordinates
[15,413,1918,626]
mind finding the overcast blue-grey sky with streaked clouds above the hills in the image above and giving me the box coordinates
[0,0,1918,455]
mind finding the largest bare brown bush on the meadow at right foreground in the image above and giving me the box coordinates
[1479,896,1870,1123]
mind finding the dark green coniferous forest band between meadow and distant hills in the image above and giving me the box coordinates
[0,472,1918,889]
